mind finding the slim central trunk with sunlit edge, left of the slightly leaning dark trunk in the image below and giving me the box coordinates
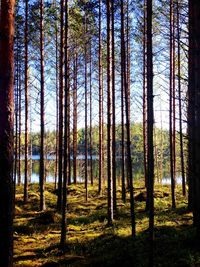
[106,0,113,225]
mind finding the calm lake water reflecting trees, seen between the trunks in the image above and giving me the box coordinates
[16,155,182,184]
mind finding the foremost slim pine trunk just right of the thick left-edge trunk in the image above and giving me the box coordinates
[24,0,29,203]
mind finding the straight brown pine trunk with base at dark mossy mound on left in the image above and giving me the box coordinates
[40,0,46,210]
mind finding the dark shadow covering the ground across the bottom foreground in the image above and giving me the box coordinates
[15,225,200,267]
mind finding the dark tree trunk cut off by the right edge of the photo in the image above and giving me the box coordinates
[188,0,200,232]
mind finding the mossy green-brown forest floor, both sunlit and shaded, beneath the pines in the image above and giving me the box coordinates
[14,183,200,267]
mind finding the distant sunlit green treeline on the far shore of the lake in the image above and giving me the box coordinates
[16,123,186,171]
